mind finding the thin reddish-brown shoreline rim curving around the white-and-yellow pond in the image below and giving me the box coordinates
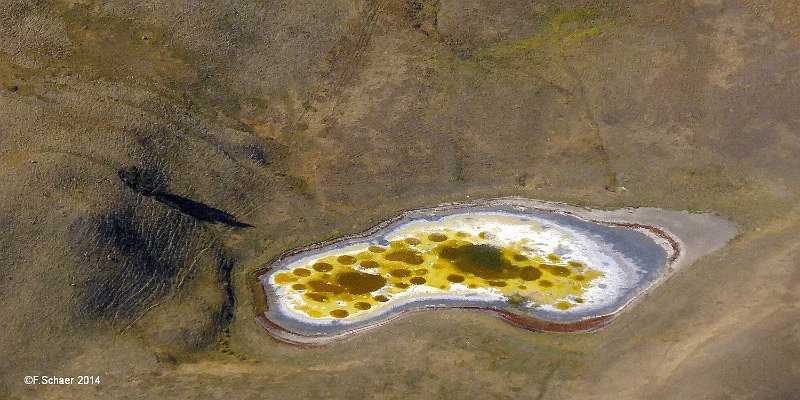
[250,199,681,347]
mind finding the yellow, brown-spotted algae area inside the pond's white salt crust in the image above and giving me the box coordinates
[273,229,603,318]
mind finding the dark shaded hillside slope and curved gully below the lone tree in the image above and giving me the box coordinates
[70,200,234,334]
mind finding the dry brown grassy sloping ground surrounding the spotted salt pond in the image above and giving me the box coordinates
[0,0,800,399]
